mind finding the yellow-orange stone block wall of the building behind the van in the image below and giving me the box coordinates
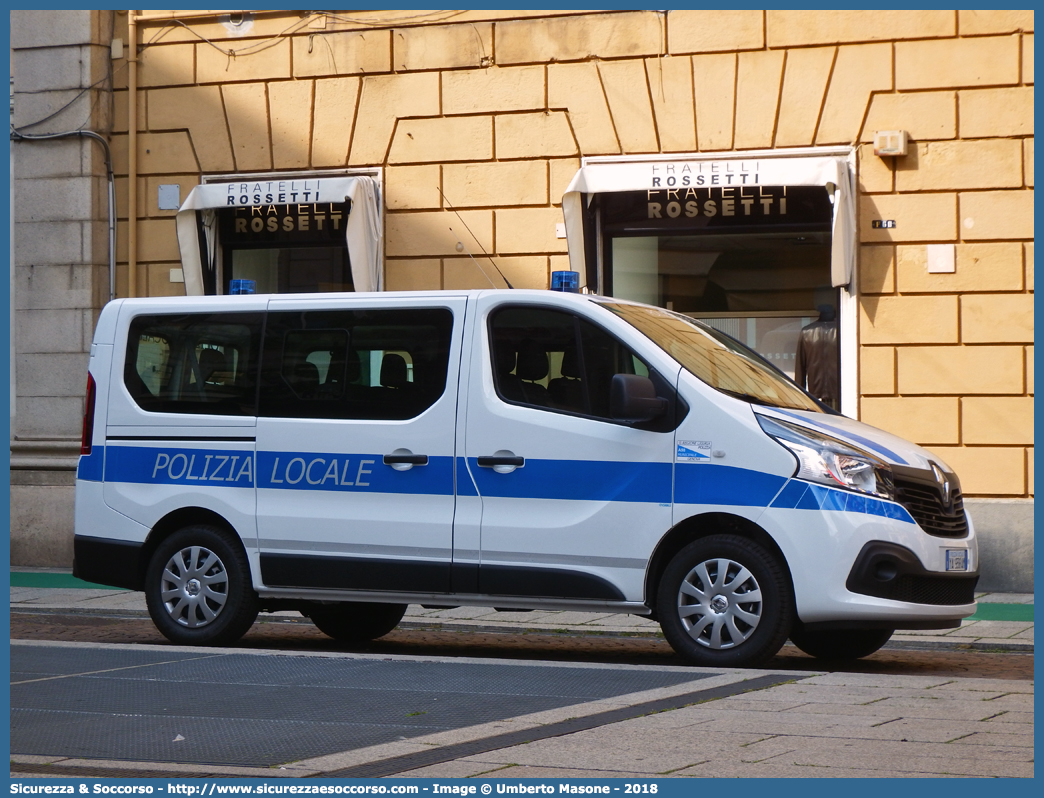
[113,10,1034,497]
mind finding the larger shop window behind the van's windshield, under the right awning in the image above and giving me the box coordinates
[595,186,839,397]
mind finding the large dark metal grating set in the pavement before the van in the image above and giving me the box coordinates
[10,646,713,767]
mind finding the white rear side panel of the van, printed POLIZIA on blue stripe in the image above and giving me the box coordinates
[97,297,263,584]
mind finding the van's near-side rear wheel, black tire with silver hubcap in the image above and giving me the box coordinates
[145,524,259,646]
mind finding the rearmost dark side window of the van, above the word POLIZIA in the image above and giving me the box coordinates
[123,313,262,416]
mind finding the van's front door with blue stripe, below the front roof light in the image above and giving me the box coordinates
[458,295,678,602]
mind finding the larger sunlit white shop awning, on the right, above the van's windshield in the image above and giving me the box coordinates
[562,154,856,287]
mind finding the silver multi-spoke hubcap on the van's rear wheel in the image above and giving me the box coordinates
[160,546,229,629]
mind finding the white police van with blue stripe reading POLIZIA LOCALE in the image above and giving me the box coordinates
[74,290,978,666]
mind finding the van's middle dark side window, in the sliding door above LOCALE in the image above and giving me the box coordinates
[259,308,453,420]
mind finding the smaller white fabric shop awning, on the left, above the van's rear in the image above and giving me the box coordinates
[177,175,384,296]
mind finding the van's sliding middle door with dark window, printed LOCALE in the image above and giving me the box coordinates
[257,295,466,592]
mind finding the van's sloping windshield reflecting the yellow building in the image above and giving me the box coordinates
[597,300,823,413]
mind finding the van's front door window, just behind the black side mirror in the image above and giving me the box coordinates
[490,306,649,419]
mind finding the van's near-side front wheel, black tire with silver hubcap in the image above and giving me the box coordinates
[657,535,793,667]
